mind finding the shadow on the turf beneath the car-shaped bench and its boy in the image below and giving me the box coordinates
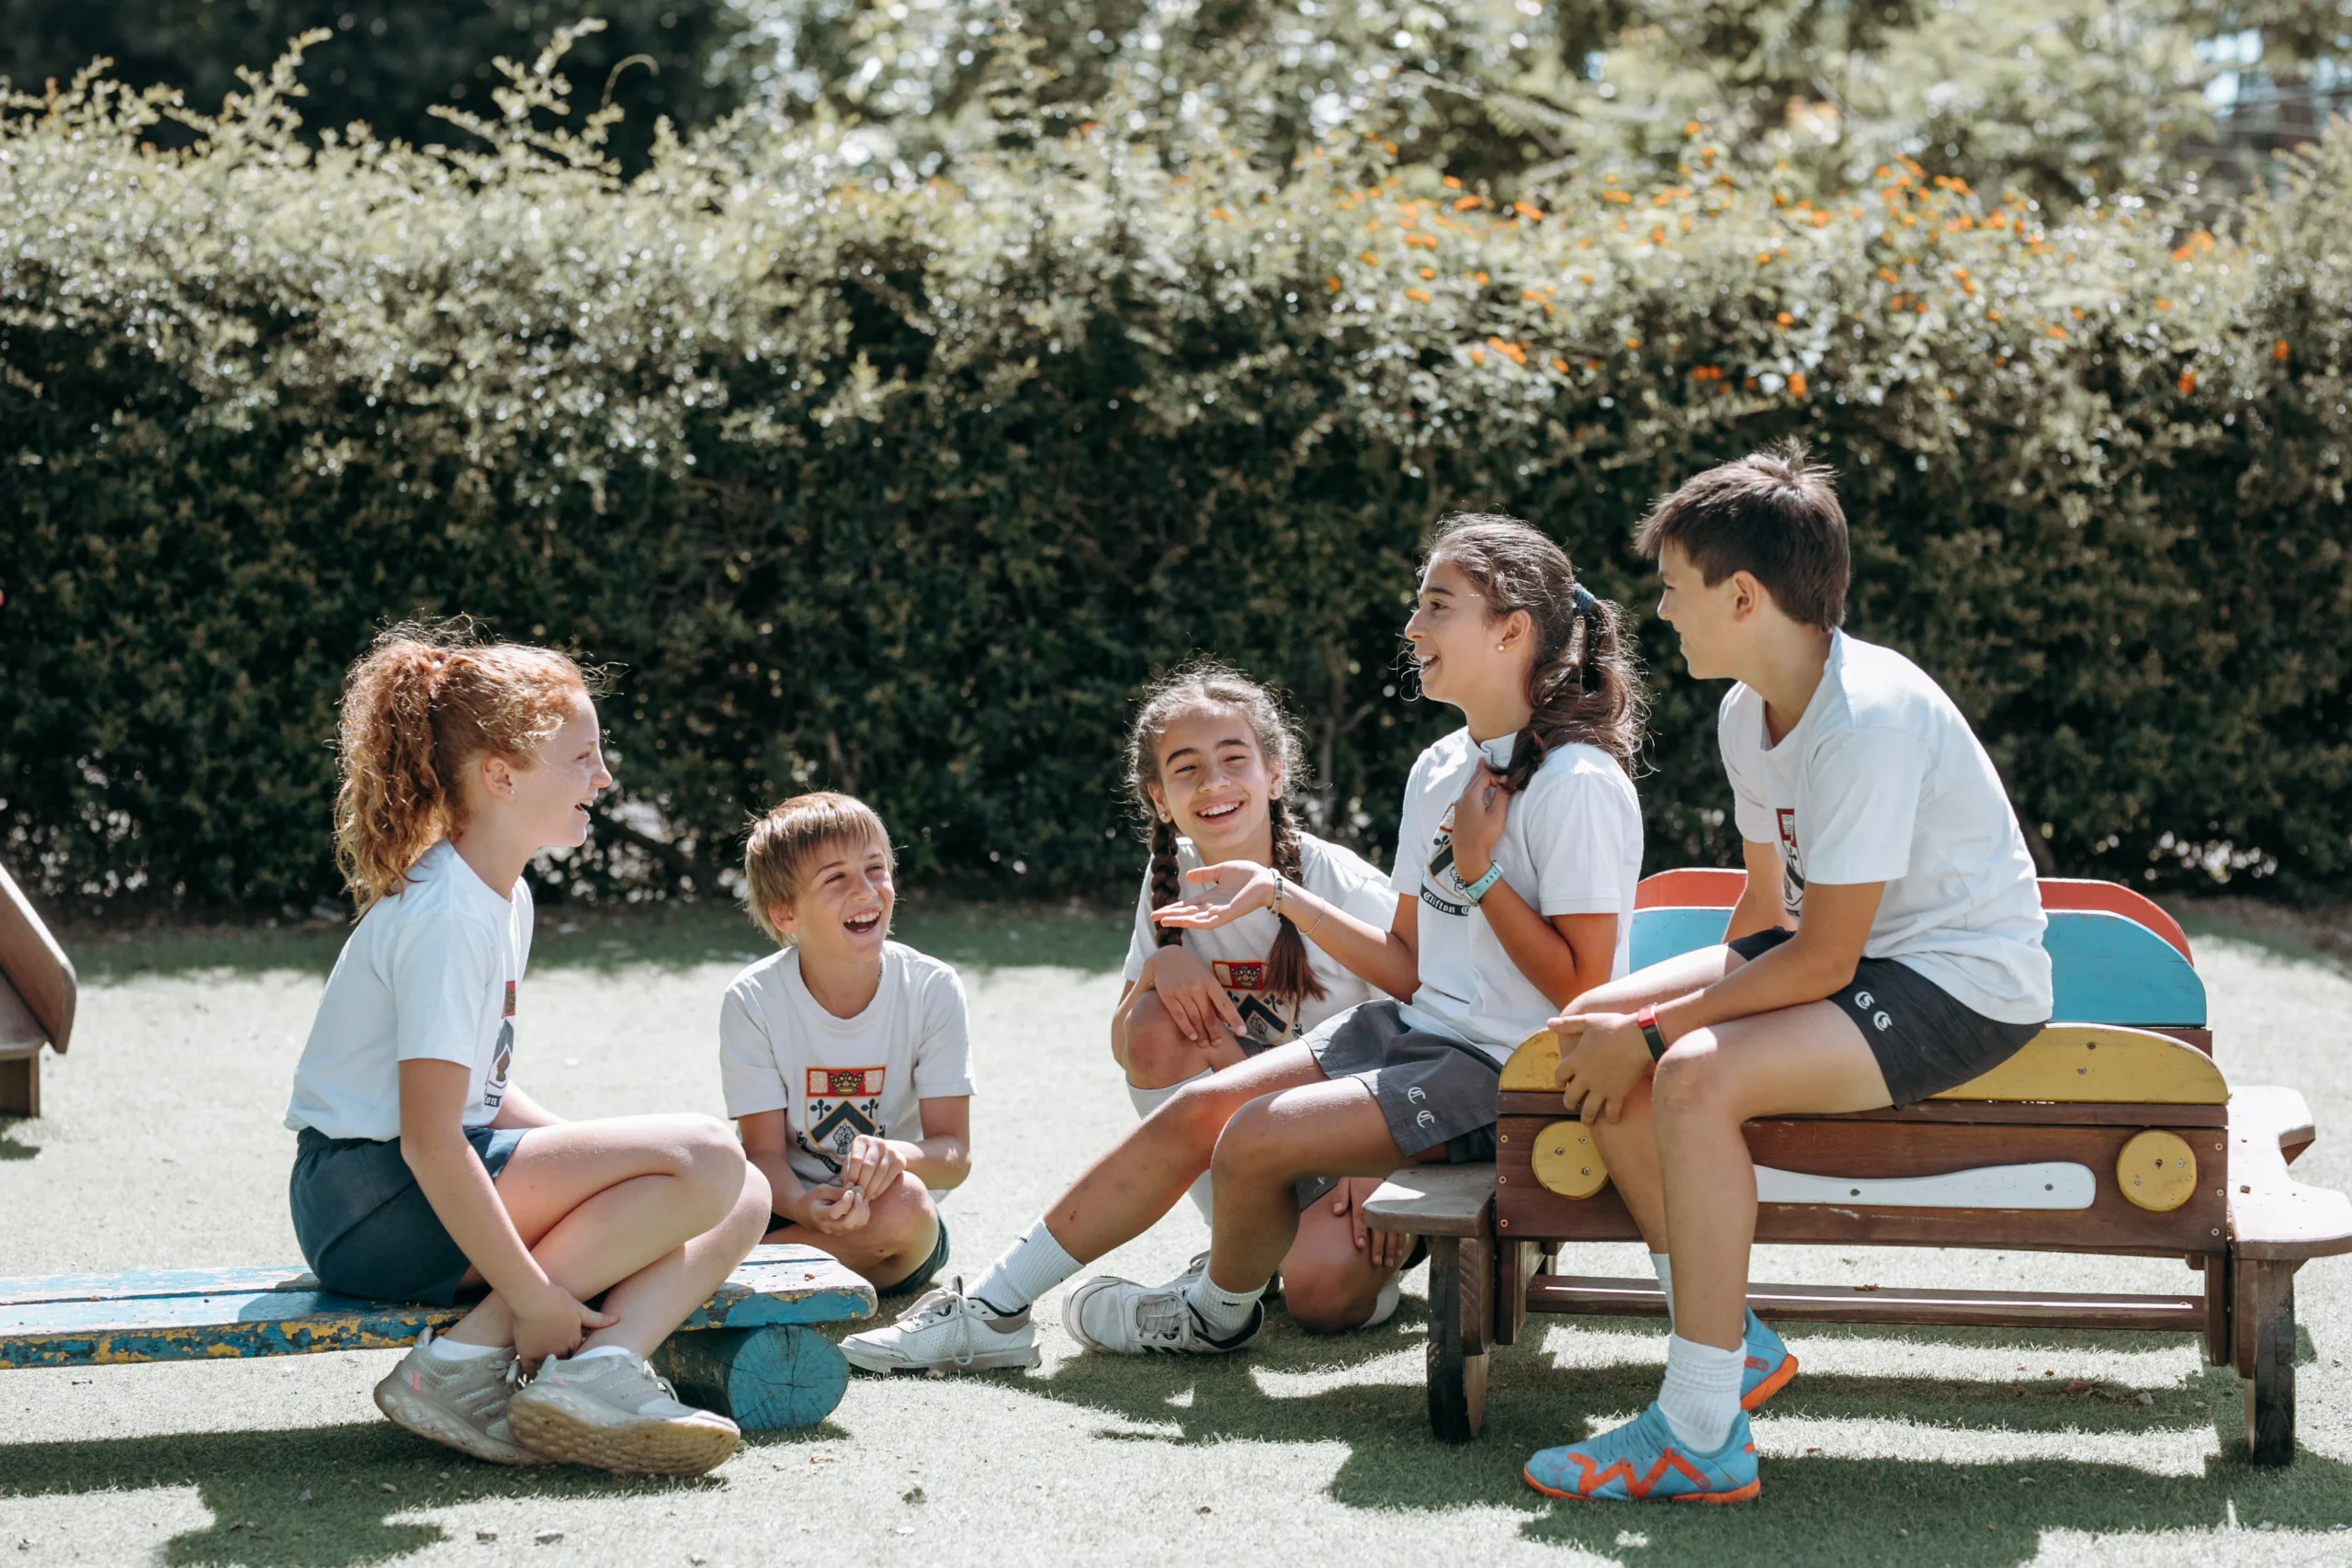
[983,1300,2352,1568]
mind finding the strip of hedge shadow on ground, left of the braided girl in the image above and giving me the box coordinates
[63,898,1126,985]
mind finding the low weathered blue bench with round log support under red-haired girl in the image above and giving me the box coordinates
[0,1246,875,1432]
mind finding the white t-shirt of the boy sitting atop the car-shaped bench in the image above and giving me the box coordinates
[1717,632,2051,1022]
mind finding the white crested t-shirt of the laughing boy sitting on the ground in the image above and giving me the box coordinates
[719,942,971,1187]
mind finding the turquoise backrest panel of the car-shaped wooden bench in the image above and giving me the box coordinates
[1633,908,2206,1030]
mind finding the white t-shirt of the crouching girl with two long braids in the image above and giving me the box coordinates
[1126,832,1397,1046]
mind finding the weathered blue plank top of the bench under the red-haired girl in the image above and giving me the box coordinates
[0,1246,875,1368]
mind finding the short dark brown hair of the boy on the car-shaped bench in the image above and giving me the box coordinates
[1634,437,1853,630]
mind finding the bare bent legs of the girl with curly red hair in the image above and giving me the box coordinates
[449,1117,769,1357]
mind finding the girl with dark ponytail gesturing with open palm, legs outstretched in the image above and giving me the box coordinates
[847,517,1642,1371]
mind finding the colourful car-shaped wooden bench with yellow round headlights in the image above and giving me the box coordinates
[1364,872,2352,1464]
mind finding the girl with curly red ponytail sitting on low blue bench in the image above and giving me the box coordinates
[285,621,769,1474]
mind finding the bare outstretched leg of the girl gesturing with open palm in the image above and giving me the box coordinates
[1045,1046,1326,1272]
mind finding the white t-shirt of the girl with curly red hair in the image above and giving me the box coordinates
[285,840,532,1143]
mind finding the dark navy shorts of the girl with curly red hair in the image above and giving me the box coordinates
[287,1126,529,1307]
